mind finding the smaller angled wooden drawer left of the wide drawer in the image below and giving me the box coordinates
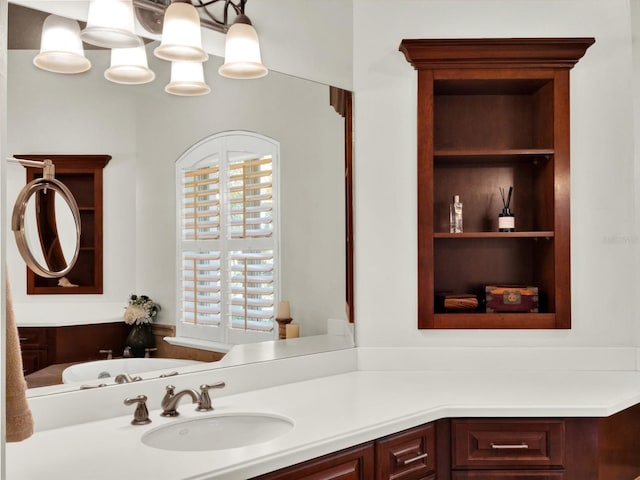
[376,424,436,480]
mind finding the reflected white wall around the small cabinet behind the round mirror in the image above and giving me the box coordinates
[4,50,137,321]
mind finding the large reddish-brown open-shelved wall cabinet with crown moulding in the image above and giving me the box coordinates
[400,38,594,328]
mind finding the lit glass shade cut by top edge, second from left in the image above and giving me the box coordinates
[80,0,141,48]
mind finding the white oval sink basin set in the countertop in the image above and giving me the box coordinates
[142,413,293,452]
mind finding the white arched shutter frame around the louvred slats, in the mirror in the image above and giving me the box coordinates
[175,131,281,345]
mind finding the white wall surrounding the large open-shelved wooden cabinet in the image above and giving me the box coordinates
[353,0,638,347]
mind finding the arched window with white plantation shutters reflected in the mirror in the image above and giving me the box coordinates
[176,132,279,344]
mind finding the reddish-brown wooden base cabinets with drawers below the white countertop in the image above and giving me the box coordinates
[251,404,640,480]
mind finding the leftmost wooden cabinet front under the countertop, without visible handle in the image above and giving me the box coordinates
[251,443,374,480]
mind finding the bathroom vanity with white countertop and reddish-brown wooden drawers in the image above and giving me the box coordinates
[6,349,640,480]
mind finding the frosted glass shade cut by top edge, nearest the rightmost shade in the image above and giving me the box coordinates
[153,2,209,62]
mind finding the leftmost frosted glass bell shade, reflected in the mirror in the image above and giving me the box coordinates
[33,15,91,73]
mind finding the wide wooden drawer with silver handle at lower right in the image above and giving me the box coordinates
[452,419,564,468]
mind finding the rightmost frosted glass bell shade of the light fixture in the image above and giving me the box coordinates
[218,15,269,79]
